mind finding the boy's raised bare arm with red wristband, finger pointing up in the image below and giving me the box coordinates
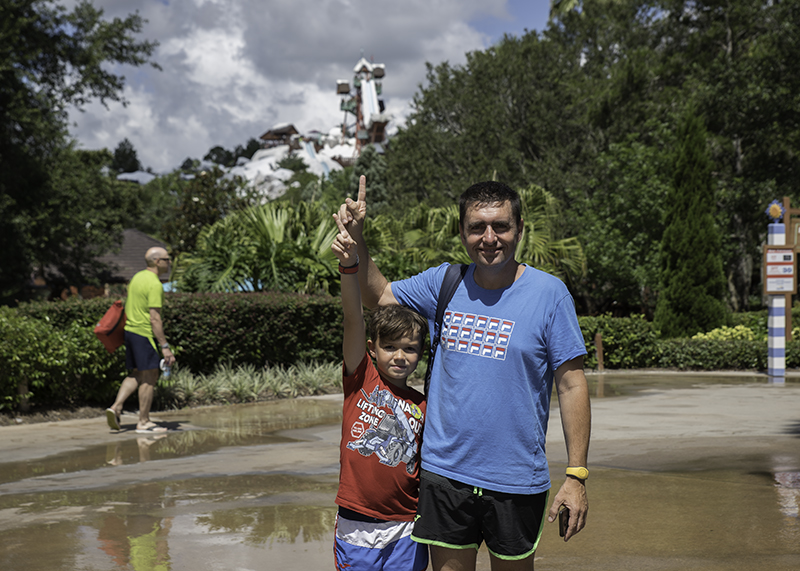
[331,214,367,375]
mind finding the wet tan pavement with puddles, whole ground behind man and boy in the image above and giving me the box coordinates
[0,372,800,571]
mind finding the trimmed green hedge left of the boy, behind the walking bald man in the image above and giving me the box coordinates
[0,293,342,408]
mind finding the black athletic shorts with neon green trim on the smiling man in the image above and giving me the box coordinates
[411,470,549,560]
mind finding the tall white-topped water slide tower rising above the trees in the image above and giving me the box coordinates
[336,55,392,156]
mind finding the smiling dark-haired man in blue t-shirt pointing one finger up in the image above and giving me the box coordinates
[338,176,591,571]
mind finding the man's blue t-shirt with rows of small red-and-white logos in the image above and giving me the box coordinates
[392,264,586,494]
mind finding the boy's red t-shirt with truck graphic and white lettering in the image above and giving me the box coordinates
[336,354,425,521]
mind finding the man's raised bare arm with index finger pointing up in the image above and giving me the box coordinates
[339,175,397,309]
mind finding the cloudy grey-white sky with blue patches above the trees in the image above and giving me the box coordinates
[64,0,550,172]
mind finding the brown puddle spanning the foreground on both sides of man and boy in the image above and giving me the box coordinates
[0,468,800,571]
